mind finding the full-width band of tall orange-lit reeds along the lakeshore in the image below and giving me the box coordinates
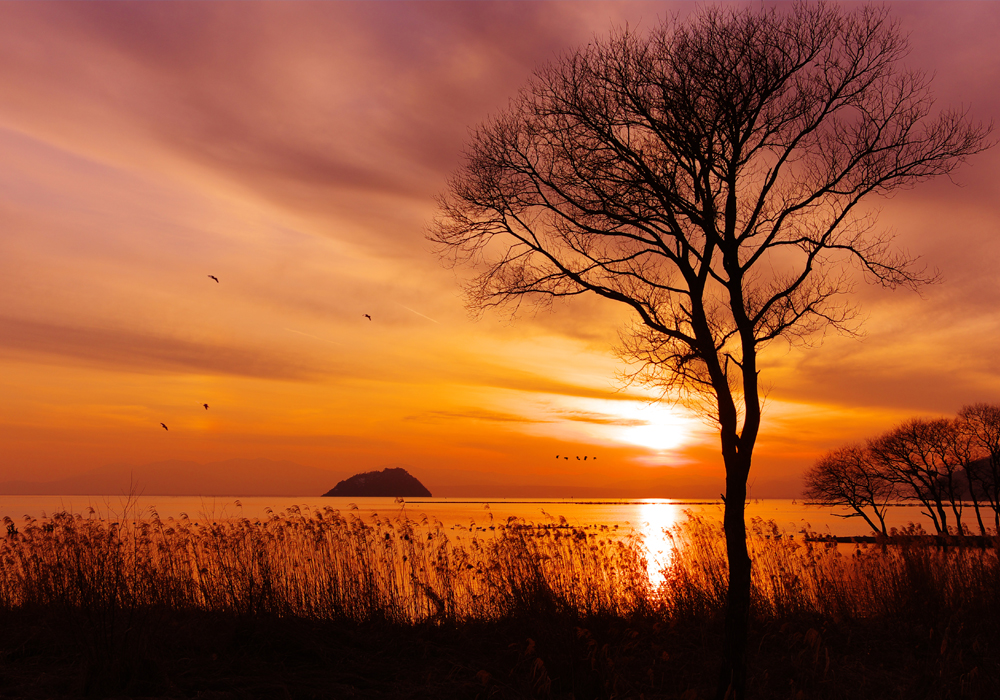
[0,508,1000,628]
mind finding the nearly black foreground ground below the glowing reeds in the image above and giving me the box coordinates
[0,611,1000,700]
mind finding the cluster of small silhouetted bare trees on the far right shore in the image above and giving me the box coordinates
[805,403,1000,535]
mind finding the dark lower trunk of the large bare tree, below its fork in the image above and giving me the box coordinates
[716,460,750,700]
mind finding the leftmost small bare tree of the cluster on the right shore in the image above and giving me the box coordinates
[804,445,896,535]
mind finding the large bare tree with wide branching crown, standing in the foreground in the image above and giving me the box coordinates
[430,3,990,698]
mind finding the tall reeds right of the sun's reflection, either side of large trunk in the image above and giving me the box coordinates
[657,515,1000,621]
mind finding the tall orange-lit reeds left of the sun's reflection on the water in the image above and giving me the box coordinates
[0,508,653,623]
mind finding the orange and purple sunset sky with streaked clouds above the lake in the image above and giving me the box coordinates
[0,2,1000,497]
